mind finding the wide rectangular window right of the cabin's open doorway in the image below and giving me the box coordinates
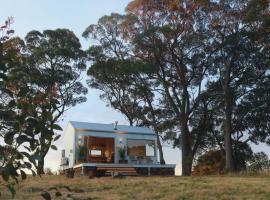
[127,139,155,157]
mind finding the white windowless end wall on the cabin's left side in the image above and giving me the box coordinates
[64,123,75,167]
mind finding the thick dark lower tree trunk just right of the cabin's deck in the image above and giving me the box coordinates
[181,124,193,176]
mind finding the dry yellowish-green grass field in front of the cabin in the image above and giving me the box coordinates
[1,176,270,200]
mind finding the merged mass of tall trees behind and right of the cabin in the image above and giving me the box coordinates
[83,0,270,175]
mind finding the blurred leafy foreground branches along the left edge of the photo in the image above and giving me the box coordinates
[0,19,62,196]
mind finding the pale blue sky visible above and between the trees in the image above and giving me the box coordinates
[0,0,270,173]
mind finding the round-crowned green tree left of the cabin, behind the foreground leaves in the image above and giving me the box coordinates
[4,29,87,177]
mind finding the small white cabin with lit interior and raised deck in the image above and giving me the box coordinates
[61,121,175,176]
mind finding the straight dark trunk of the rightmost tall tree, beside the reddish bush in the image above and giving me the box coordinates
[224,87,234,172]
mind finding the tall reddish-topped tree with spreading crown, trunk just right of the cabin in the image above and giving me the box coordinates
[84,1,215,173]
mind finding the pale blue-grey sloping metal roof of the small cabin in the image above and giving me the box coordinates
[69,121,155,135]
